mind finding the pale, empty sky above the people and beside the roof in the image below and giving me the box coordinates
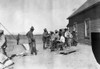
[0,0,86,34]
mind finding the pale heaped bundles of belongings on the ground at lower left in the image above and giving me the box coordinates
[0,44,29,69]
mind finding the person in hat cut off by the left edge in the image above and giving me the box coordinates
[0,30,7,56]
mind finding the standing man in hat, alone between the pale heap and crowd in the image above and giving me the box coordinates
[26,26,37,55]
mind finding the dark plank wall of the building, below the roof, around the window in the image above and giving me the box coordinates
[69,3,100,45]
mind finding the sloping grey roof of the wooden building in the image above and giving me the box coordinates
[68,0,100,19]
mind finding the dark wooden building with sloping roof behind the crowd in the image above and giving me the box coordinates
[67,0,100,44]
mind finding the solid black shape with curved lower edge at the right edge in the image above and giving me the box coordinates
[91,32,100,64]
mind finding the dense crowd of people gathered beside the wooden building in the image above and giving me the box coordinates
[42,28,78,51]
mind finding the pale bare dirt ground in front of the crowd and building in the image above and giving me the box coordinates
[7,35,97,69]
